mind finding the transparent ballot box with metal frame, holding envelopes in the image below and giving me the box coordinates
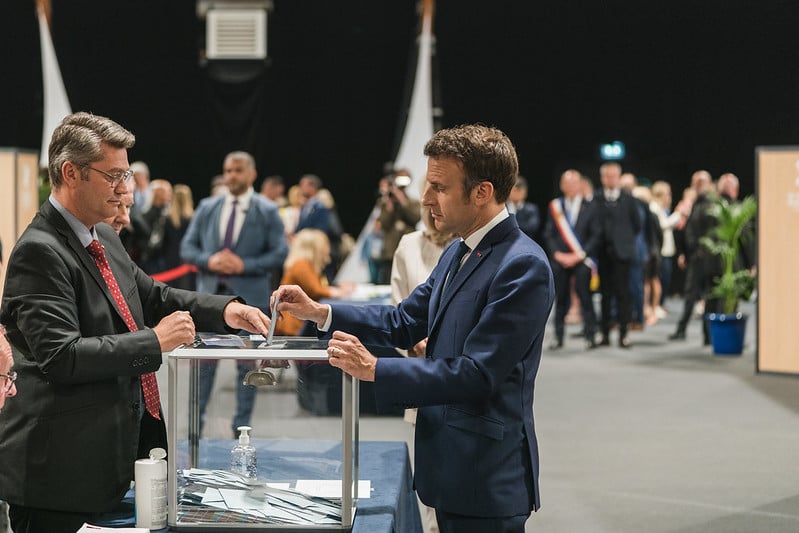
[165,334,360,532]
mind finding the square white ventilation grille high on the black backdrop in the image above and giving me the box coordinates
[205,9,266,59]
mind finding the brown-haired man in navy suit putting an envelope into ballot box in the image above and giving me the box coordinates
[273,126,555,533]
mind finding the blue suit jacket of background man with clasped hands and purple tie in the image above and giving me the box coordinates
[180,194,288,313]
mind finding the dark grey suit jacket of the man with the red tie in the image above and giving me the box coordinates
[0,201,232,512]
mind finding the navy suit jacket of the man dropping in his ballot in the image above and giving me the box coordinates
[322,217,554,517]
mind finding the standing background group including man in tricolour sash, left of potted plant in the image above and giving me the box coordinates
[541,162,755,349]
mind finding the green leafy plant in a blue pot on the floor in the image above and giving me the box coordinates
[700,196,757,355]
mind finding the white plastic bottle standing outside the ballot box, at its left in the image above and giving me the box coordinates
[133,448,167,530]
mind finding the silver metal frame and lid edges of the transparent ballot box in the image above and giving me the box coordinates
[164,334,360,533]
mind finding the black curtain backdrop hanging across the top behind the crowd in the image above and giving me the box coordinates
[0,0,799,233]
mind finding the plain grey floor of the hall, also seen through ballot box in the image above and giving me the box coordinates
[159,301,799,533]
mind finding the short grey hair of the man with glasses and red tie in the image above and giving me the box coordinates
[47,112,136,189]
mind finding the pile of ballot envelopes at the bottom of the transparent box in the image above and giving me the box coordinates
[178,468,370,525]
